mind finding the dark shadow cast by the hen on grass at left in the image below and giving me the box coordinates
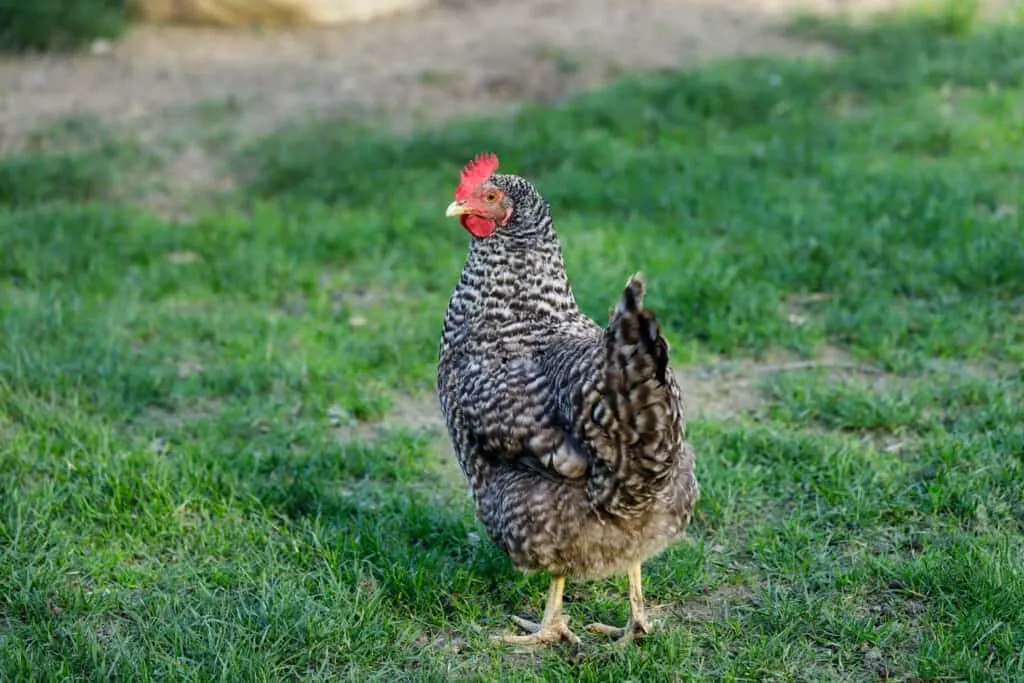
[252,446,534,622]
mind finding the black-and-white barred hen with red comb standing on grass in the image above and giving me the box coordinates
[437,154,699,644]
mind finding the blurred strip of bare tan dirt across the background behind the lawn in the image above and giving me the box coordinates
[0,0,999,147]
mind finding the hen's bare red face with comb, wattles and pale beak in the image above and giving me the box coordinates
[445,153,513,238]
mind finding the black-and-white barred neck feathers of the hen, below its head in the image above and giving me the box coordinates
[442,217,581,354]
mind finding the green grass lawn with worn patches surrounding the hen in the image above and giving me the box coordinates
[0,6,1024,681]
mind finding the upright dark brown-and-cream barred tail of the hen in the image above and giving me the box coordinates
[589,273,685,517]
